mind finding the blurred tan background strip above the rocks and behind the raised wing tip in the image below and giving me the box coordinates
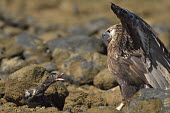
[0,0,170,46]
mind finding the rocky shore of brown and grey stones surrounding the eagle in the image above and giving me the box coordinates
[0,0,170,113]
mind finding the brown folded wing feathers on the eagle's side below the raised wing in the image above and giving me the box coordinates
[119,54,148,86]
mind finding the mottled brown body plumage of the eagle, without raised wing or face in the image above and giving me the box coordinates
[107,25,148,99]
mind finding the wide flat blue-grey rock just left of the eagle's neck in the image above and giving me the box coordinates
[47,35,106,54]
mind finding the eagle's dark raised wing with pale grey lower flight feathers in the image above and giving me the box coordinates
[111,4,170,89]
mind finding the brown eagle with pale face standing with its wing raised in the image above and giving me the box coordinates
[102,3,170,110]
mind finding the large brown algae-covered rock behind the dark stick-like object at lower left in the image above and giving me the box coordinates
[5,65,45,104]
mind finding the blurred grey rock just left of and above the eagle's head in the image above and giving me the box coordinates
[85,18,110,35]
